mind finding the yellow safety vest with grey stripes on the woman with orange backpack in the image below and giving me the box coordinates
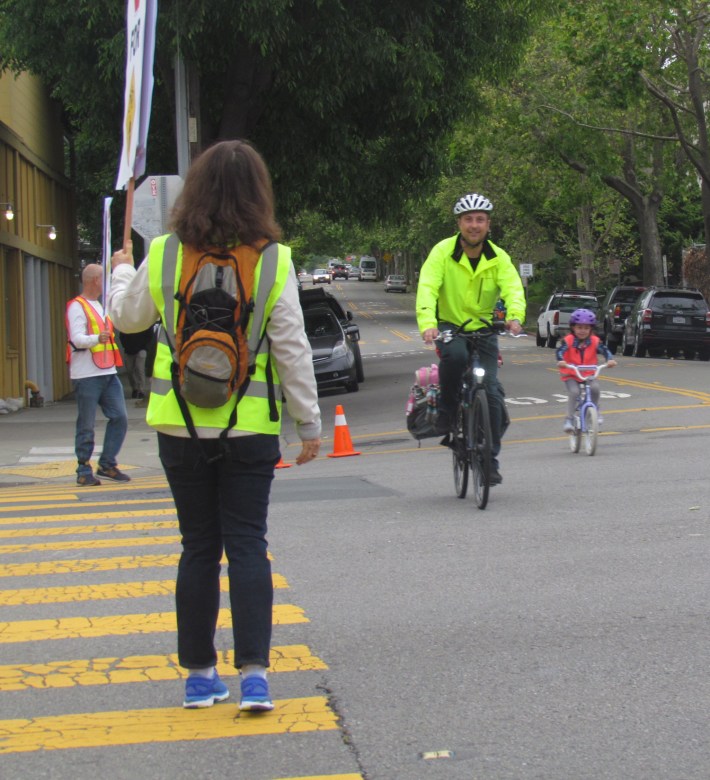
[146,234,291,435]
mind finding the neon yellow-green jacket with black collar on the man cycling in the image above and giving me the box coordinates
[417,233,525,333]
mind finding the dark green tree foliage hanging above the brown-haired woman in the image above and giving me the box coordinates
[0,0,547,244]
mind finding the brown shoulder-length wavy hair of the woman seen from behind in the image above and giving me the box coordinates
[171,141,281,250]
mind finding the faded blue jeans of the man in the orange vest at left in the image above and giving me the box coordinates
[73,374,128,477]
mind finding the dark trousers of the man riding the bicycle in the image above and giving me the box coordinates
[437,322,507,468]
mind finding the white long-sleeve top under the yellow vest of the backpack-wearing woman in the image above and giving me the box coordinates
[108,256,321,441]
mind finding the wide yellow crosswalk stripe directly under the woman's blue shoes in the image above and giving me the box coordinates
[0,696,338,753]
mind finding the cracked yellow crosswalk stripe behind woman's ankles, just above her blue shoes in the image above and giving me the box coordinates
[0,645,328,691]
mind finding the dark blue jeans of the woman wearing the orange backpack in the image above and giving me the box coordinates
[158,433,280,669]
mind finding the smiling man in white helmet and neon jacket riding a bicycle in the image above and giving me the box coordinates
[416,192,525,485]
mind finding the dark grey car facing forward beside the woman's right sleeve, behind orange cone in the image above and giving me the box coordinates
[303,306,358,393]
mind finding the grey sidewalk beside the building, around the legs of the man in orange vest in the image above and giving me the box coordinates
[0,398,163,488]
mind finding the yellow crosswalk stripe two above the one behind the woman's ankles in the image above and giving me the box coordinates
[0,573,288,607]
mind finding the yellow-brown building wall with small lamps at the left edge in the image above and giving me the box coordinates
[0,72,79,400]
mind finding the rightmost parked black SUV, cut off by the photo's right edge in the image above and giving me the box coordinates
[621,287,710,360]
